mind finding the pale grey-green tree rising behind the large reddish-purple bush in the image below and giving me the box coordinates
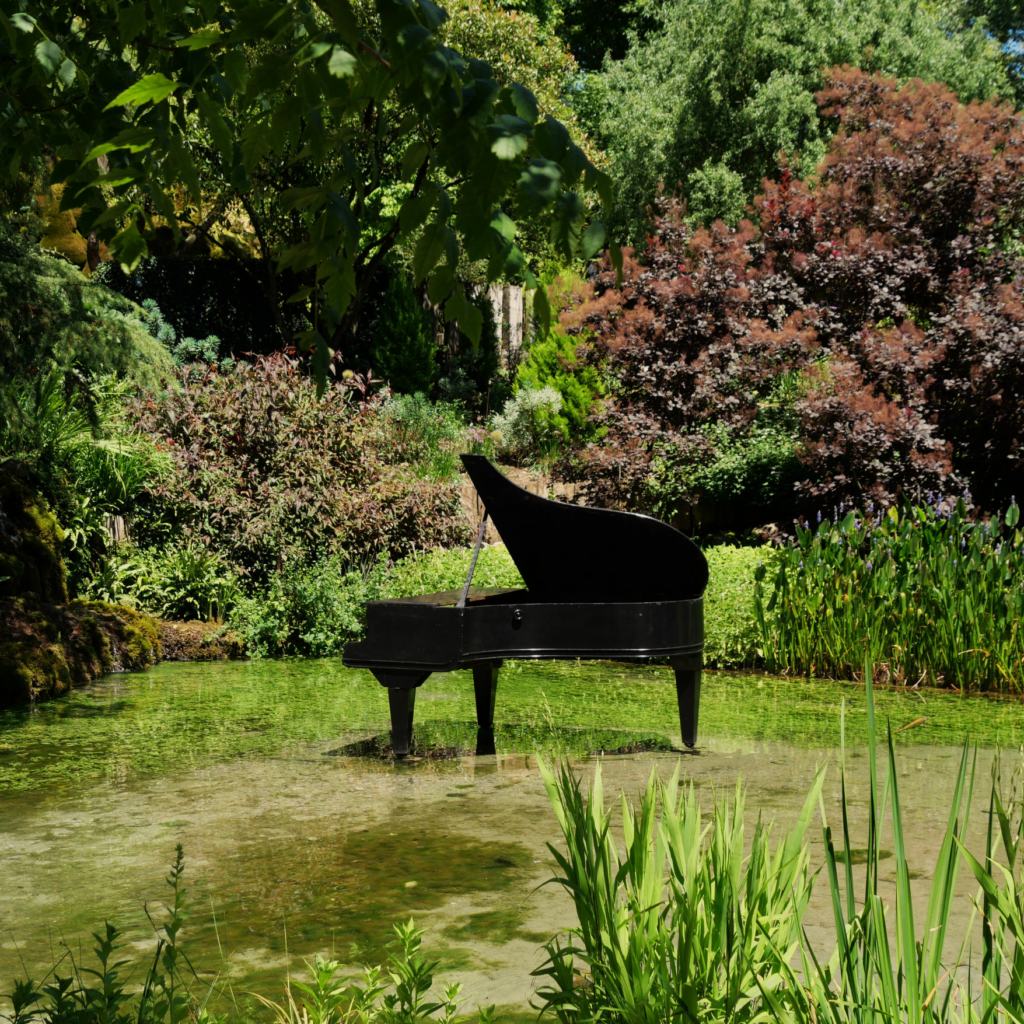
[584,0,1014,245]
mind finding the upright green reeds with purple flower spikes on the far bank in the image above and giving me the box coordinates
[755,502,1024,691]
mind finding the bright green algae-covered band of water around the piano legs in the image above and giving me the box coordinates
[0,658,1024,792]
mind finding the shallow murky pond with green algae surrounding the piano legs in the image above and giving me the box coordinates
[0,659,1024,1016]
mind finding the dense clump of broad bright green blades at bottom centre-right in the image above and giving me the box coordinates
[534,762,824,1024]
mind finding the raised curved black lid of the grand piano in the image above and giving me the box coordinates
[462,455,708,602]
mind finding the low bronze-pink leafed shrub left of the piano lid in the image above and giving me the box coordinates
[126,354,470,584]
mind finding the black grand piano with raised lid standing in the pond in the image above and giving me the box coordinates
[344,455,708,757]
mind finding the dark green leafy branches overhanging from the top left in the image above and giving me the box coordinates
[0,0,611,389]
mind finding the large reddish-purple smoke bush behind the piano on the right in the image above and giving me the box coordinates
[561,68,1024,512]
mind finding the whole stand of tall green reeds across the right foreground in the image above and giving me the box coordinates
[535,663,1011,1024]
